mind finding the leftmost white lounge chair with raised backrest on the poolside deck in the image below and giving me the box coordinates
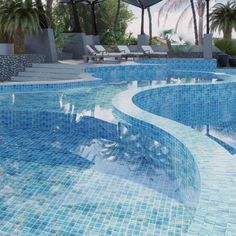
[84,45,121,62]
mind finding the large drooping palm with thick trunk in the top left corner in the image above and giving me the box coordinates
[0,0,42,53]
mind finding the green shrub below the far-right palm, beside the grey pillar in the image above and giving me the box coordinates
[214,39,236,56]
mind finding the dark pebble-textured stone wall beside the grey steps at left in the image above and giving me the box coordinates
[0,54,45,81]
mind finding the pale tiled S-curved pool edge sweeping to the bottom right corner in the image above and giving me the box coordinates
[113,85,236,235]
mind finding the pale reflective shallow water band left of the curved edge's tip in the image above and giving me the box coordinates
[0,76,218,122]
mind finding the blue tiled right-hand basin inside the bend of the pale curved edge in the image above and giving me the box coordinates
[137,84,236,154]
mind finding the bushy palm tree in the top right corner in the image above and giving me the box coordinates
[210,2,236,40]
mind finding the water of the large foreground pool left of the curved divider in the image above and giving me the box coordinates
[0,75,206,235]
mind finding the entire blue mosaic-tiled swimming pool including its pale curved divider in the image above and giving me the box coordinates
[0,60,236,236]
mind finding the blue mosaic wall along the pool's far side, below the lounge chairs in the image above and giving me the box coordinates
[0,59,217,93]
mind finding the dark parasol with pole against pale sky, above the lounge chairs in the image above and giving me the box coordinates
[122,0,162,34]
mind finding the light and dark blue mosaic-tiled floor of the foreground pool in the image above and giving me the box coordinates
[0,128,194,236]
